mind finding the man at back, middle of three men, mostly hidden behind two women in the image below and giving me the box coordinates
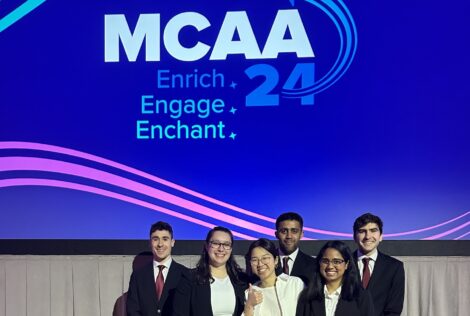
[276,212,316,284]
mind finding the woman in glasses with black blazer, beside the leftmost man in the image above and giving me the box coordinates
[173,226,248,316]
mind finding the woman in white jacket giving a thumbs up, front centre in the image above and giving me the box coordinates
[244,238,304,316]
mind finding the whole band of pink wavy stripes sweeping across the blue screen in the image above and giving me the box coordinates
[0,142,470,240]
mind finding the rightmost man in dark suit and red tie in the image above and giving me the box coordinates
[353,213,405,316]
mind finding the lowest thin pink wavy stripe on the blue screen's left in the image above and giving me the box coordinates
[0,178,256,240]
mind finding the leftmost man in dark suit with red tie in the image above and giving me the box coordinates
[126,222,188,316]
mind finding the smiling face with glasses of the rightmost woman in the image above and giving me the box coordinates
[320,248,349,285]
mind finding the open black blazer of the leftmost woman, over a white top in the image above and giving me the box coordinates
[173,270,248,316]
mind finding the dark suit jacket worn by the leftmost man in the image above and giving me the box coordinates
[126,260,189,316]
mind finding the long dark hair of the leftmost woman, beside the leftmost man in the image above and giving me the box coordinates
[196,226,243,284]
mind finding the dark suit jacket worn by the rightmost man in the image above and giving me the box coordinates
[354,251,405,316]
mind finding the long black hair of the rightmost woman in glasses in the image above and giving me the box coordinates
[299,240,361,302]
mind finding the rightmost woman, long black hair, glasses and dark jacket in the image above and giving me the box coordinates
[297,240,374,316]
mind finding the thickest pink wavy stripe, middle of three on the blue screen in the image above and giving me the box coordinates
[0,157,280,236]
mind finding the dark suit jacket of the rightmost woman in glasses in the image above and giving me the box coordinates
[296,289,374,316]
